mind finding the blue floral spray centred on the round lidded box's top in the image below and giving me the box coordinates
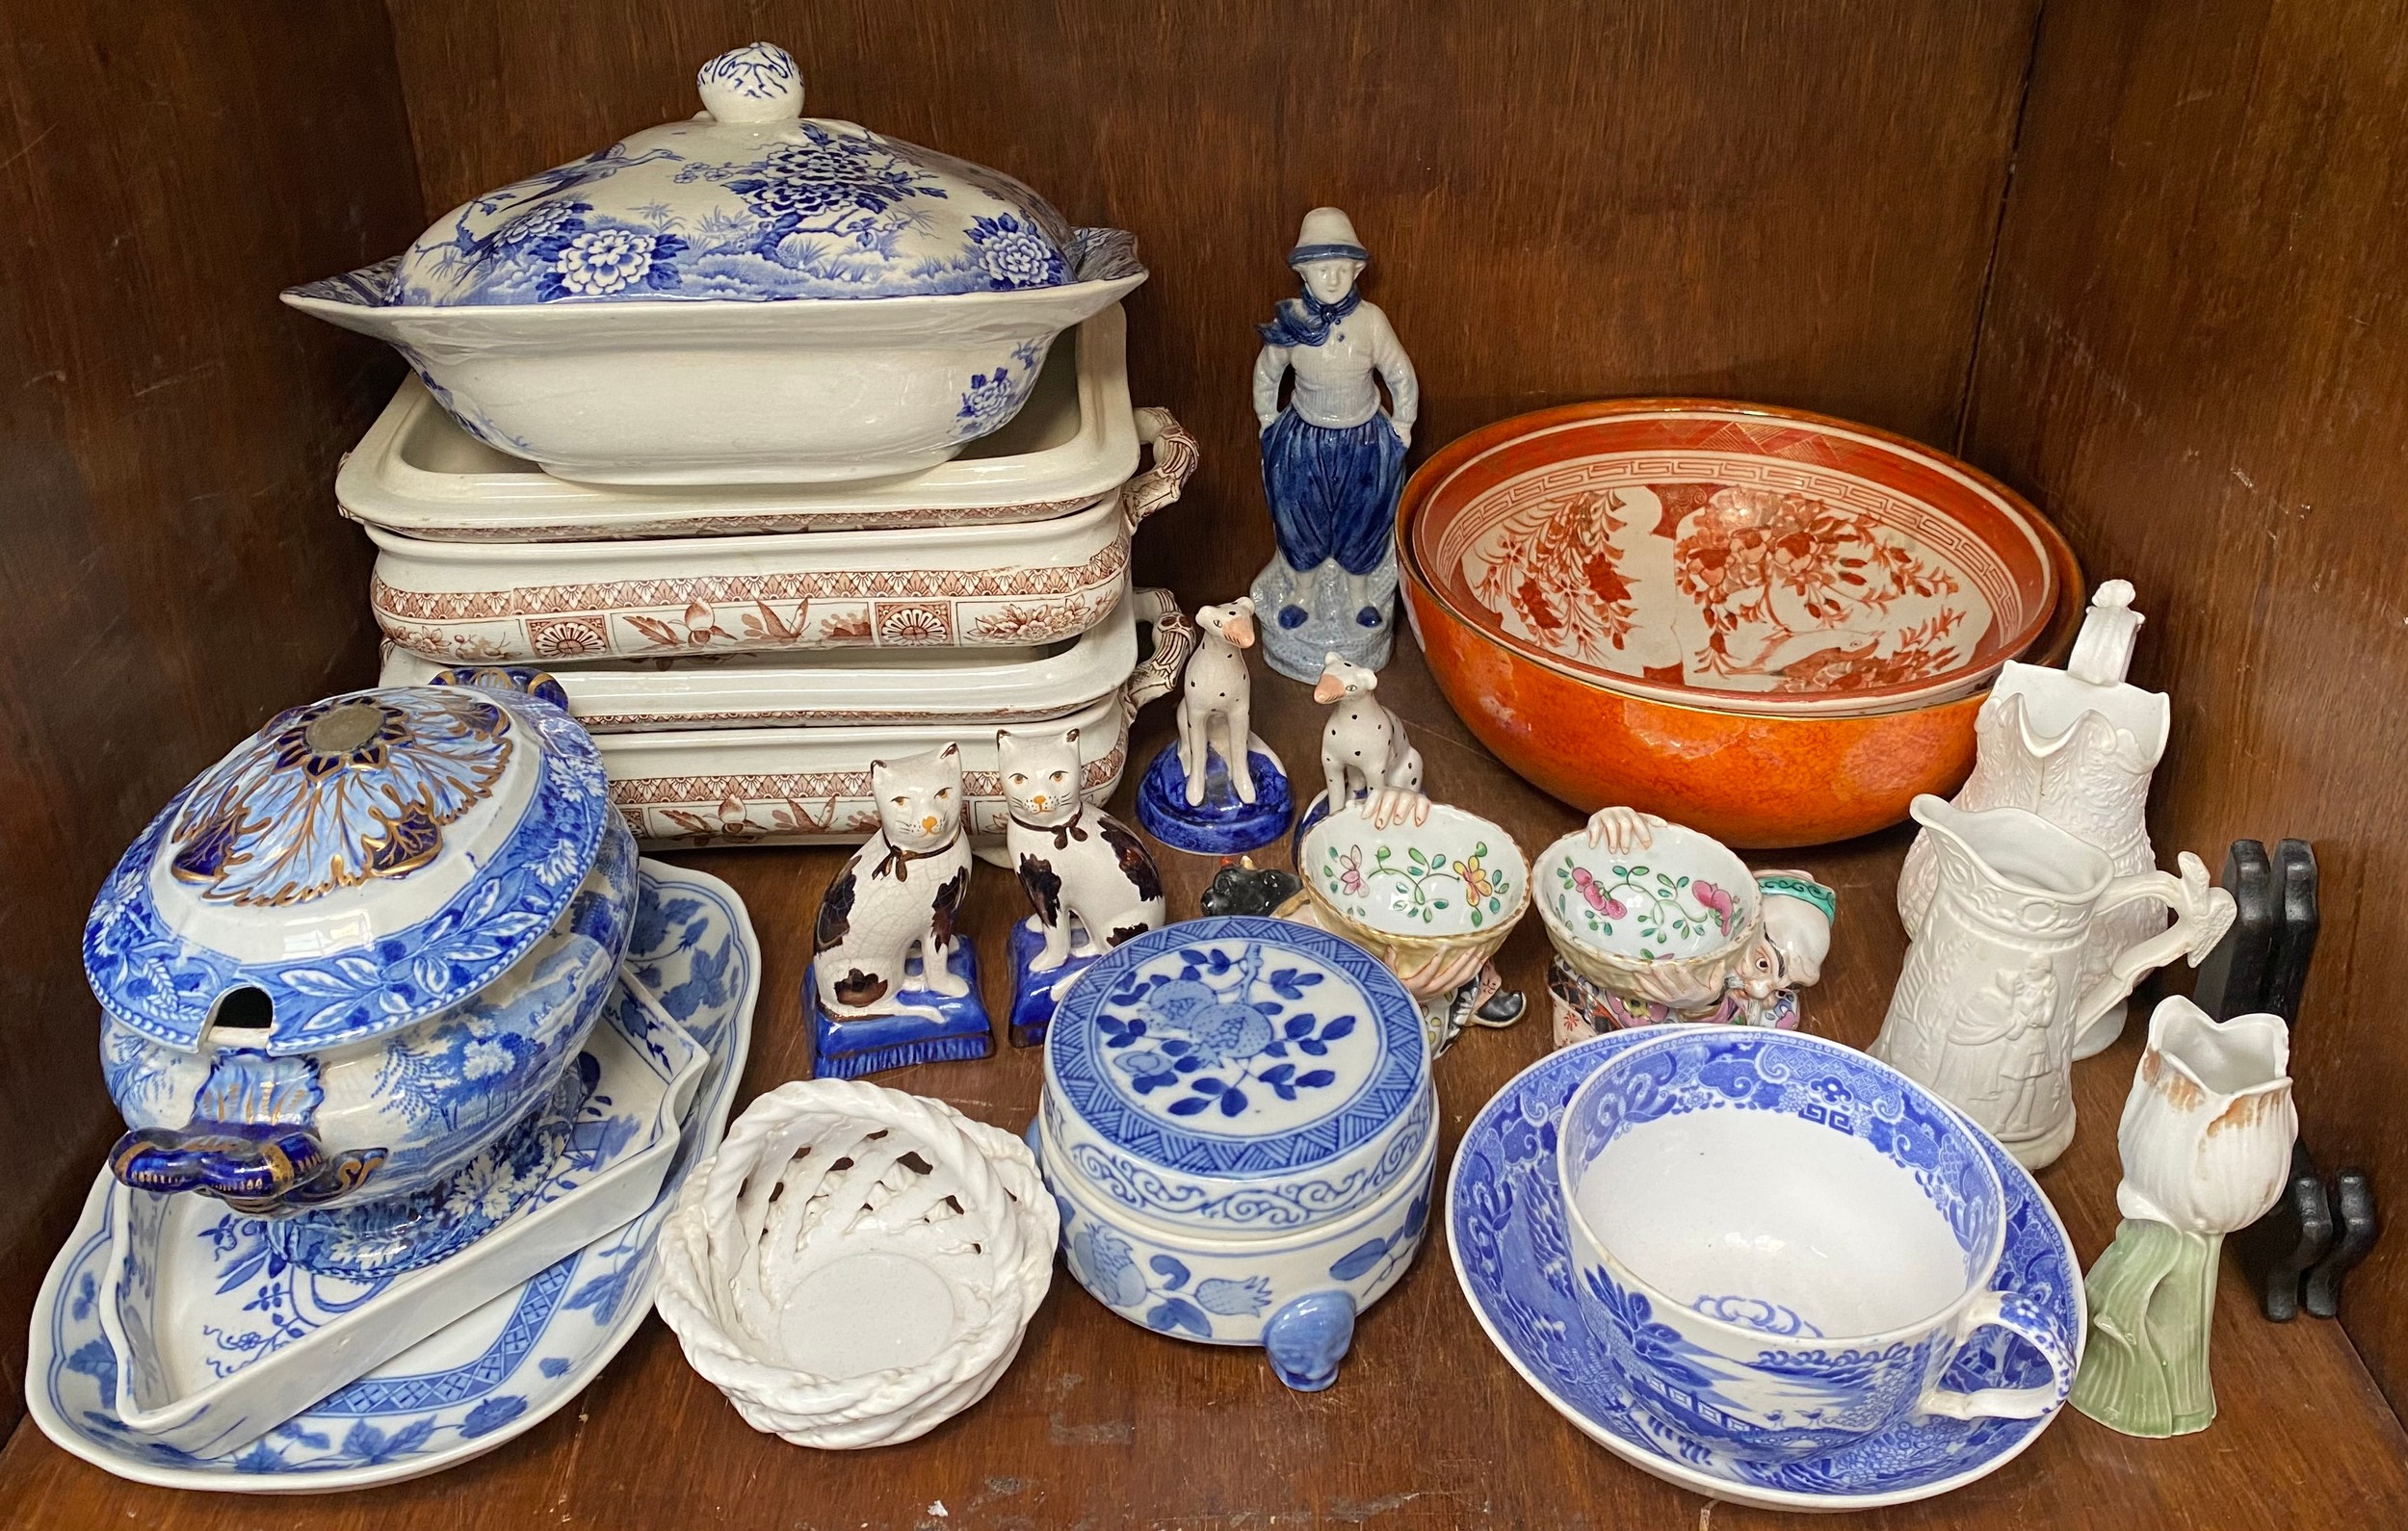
[1096,942,1358,1117]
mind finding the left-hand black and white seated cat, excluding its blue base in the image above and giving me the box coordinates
[812,744,971,1025]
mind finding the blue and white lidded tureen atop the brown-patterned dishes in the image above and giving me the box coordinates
[284,43,1146,484]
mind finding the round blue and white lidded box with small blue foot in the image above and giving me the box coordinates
[1031,915,1438,1389]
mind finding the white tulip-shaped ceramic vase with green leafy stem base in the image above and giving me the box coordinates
[2074,997,2300,1438]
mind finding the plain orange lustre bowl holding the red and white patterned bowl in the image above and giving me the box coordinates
[1397,411,2083,850]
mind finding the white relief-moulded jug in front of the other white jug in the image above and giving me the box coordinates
[1871,794,2233,1170]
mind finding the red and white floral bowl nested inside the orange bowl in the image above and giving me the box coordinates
[1400,400,2059,717]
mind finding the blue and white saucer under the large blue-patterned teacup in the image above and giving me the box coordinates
[1448,1030,2090,1510]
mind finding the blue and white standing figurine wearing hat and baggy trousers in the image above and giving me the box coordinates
[1252,207,1421,684]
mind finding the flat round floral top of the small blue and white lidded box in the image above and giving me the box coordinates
[1045,915,1428,1182]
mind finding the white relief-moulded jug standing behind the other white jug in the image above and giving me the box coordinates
[1898,581,2172,1059]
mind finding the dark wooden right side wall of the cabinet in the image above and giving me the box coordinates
[1965,0,2408,1409]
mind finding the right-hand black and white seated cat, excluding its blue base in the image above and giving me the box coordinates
[995,730,1164,973]
